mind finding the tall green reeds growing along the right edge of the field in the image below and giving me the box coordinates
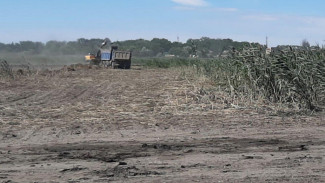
[138,47,325,111]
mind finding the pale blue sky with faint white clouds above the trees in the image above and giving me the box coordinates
[0,0,325,46]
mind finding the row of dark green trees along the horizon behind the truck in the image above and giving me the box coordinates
[0,37,259,58]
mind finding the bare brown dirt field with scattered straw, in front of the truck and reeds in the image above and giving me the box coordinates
[0,66,325,183]
